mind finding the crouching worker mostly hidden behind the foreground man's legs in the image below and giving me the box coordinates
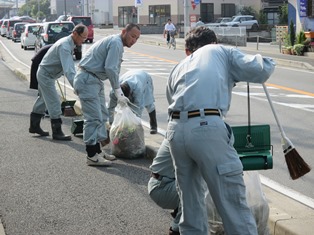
[148,139,181,235]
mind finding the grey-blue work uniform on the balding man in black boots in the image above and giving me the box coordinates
[32,35,76,119]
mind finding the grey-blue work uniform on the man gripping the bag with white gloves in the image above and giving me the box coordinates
[74,34,124,145]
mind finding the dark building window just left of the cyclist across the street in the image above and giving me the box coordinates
[148,5,171,26]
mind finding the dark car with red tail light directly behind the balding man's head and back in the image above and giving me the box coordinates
[35,21,82,60]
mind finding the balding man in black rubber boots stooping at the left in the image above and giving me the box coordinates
[29,24,88,140]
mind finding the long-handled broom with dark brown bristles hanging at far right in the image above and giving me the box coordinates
[263,83,311,180]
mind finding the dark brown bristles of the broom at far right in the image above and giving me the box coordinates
[284,146,311,180]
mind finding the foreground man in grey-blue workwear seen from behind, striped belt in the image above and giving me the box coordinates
[166,26,275,235]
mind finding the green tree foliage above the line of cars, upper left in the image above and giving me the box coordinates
[19,0,50,19]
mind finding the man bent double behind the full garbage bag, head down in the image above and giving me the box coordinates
[108,69,157,134]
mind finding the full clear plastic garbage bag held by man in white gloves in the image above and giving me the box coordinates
[109,104,146,159]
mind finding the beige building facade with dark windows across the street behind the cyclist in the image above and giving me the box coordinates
[113,0,262,27]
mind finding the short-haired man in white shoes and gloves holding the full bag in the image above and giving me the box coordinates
[74,23,141,166]
